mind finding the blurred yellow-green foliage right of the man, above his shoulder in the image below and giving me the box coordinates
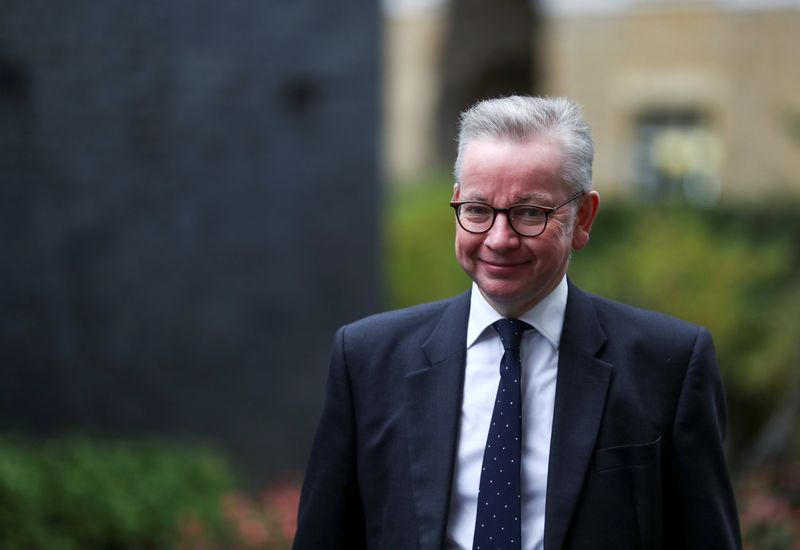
[570,204,800,448]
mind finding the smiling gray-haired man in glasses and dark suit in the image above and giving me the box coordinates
[294,96,741,550]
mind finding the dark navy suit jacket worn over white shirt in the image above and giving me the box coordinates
[294,283,741,550]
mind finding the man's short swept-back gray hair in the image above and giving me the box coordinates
[454,96,594,193]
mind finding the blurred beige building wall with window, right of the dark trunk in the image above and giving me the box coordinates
[543,2,800,204]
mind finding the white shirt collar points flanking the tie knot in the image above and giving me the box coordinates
[467,275,568,349]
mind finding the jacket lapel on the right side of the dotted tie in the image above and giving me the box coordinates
[544,282,611,550]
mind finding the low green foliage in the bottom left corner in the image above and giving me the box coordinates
[0,438,233,550]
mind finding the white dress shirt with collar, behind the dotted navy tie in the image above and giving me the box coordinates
[445,276,567,550]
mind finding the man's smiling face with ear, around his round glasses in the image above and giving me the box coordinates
[454,139,598,317]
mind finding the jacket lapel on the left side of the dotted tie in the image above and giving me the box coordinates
[406,293,469,550]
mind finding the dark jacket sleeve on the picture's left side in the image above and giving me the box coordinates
[292,327,366,550]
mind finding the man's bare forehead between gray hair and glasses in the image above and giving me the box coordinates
[459,138,568,202]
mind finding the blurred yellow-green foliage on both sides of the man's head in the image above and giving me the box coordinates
[386,178,800,462]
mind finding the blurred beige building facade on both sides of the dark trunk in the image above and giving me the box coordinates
[384,0,800,205]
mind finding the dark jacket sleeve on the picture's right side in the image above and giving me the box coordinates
[664,328,742,550]
